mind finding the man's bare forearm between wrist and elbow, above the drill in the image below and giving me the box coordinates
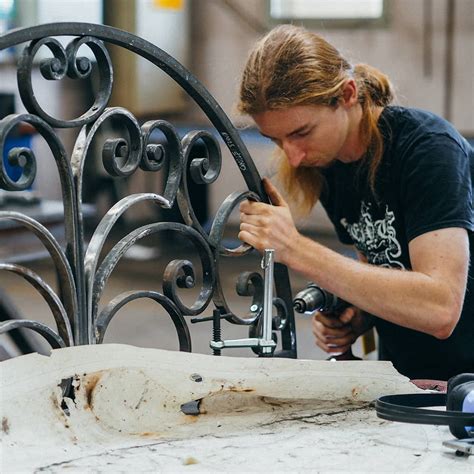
[285,232,459,338]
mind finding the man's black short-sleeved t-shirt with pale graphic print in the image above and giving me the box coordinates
[321,106,474,380]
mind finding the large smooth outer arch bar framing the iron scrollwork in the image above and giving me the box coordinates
[0,23,296,357]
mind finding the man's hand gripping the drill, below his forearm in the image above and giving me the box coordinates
[312,306,373,353]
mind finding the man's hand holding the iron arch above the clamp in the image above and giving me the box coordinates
[238,178,300,263]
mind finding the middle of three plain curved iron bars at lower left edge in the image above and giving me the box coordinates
[0,263,74,346]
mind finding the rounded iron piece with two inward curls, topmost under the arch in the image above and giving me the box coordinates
[17,32,113,128]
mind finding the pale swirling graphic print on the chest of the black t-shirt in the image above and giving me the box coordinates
[341,201,405,270]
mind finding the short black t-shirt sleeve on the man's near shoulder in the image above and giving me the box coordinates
[400,135,474,241]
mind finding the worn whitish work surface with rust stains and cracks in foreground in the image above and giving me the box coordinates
[0,345,474,473]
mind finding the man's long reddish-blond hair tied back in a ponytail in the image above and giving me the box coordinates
[237,25,394,214]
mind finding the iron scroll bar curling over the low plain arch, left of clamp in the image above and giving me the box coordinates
[92,222,215,321]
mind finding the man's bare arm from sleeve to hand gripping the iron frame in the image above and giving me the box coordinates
[239,180,469,339]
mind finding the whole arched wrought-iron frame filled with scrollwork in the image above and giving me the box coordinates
[0,23,296,357]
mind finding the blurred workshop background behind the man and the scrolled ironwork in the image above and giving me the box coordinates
[0,0,474,359]
